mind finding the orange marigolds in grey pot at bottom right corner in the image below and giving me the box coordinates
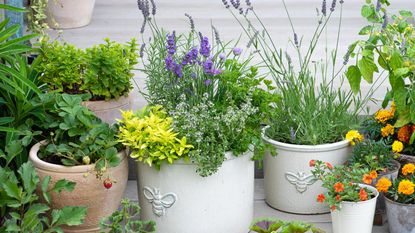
[376,163,415,233]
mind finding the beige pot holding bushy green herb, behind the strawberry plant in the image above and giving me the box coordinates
[82,95,131,124]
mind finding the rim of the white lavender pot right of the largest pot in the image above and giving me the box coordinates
[262,126,350,152]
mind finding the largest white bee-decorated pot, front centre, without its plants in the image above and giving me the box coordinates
[137,149,254,233]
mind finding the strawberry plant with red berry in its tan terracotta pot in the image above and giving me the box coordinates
[29,94,128,232]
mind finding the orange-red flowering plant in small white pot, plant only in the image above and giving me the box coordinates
[310,160,377,210]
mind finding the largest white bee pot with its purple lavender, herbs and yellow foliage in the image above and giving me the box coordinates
[119,1,275,233]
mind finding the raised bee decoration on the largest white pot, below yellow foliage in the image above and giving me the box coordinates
[143,186,177,217]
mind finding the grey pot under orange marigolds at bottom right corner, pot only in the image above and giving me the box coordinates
[385,197,415,233]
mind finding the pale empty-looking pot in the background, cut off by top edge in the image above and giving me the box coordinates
[46,0,95,29]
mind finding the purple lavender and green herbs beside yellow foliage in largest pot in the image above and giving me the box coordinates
[138,0,277,176]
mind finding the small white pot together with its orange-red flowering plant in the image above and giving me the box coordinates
[310,160,379,233]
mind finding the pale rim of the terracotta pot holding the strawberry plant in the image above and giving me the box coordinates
[29,140,127,173]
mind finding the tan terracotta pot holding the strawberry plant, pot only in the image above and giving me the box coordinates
[29,142,128,233]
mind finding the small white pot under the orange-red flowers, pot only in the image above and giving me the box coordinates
[331,184,379,233]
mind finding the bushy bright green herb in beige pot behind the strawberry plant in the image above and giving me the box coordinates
[85,39,138,100]
